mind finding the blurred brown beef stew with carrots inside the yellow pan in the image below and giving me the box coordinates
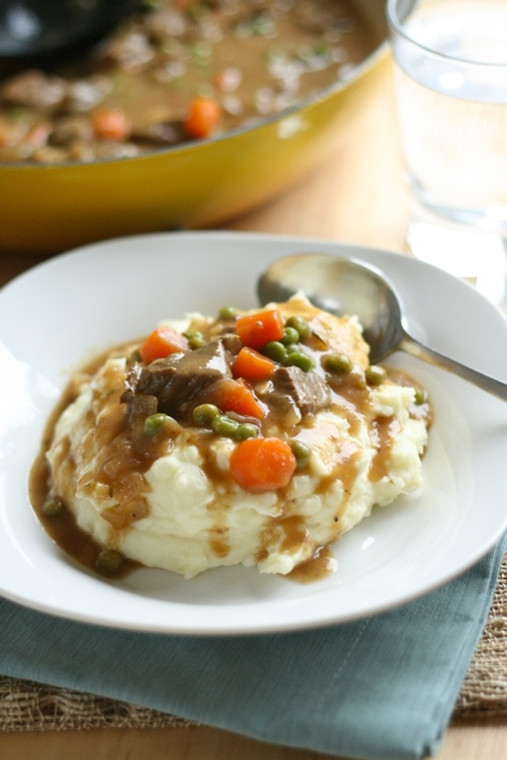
[0,0,377,163]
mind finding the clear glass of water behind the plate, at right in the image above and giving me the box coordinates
[387,0,507,303]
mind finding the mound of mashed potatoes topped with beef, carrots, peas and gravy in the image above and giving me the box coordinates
[39,296,428,578]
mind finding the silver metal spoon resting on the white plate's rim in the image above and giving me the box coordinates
[257,254,507,401]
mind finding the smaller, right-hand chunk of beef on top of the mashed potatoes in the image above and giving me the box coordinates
[263,367,331,415]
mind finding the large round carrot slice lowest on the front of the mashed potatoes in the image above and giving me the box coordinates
[229,438,296,493]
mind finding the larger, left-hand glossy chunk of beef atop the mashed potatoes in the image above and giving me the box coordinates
[123,340,232,419]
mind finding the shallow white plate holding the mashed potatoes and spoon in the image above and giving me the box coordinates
[0,233,506,634]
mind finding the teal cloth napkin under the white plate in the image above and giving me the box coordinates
[0,537,507,760]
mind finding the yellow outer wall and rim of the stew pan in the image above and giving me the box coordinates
[0,0,388,254]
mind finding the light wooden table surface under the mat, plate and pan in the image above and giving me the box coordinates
[0,63,507,760]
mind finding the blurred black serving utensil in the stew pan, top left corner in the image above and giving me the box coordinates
[0,0,140,64]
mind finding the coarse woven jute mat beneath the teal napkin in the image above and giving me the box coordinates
[0,555,507,731]
